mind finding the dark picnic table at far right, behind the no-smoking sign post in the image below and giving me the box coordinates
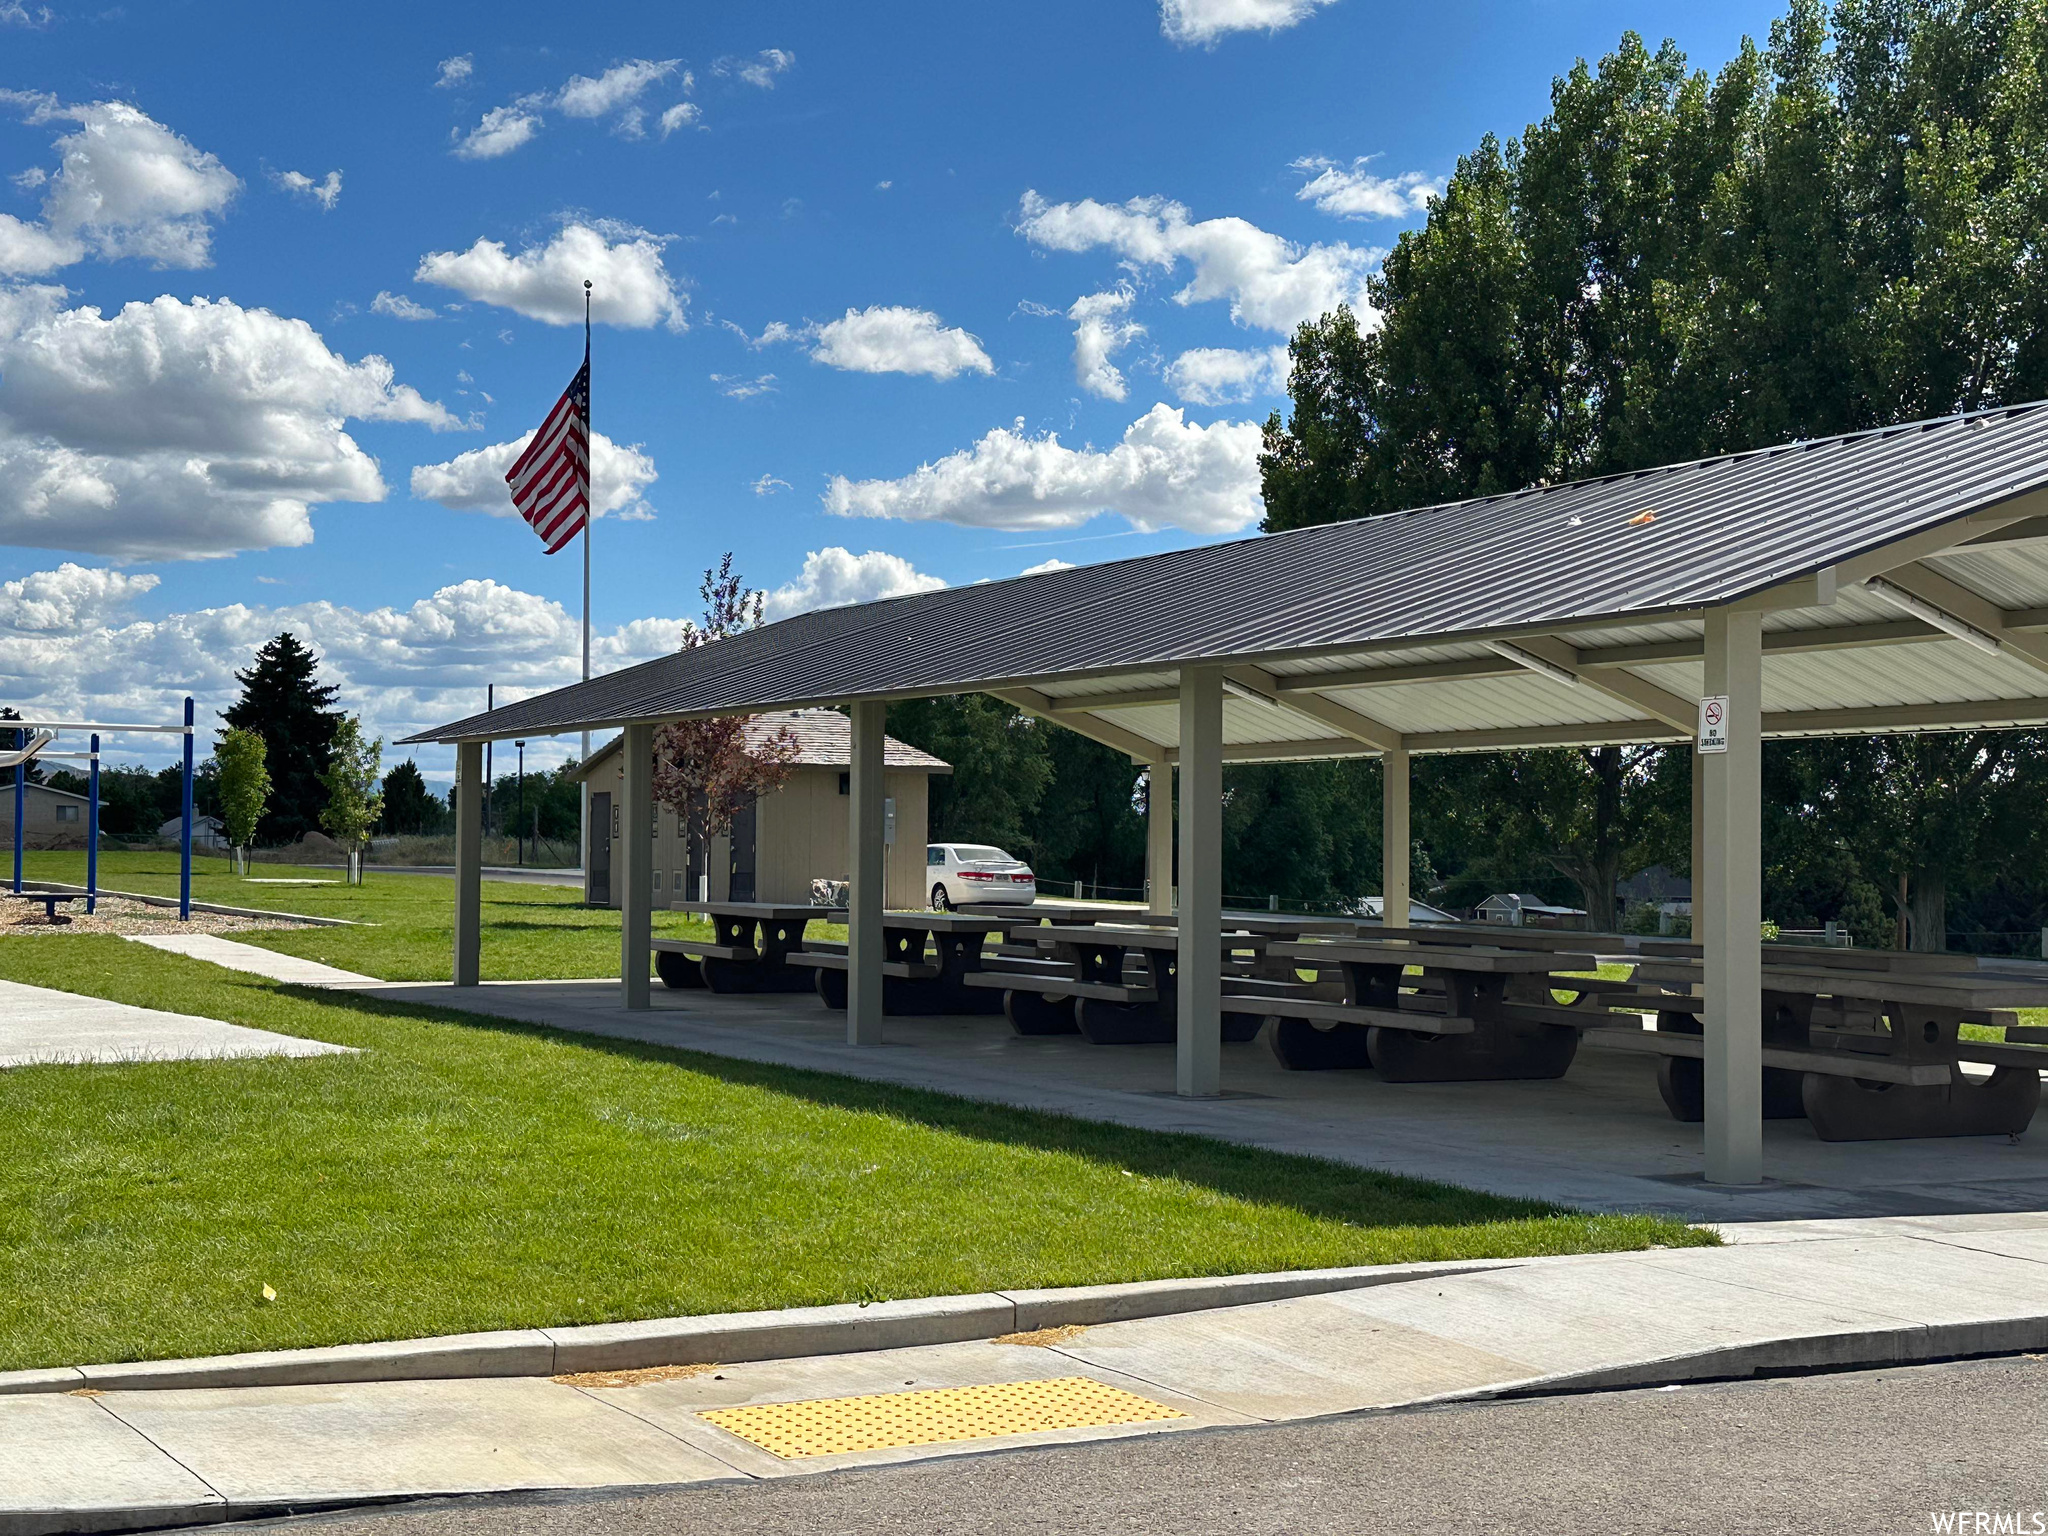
[1548,962,2048,1141]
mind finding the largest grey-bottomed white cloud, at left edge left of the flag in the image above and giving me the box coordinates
[0,287,459,559]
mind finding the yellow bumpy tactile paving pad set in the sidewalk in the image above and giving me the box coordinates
[698,1376,1188,1460]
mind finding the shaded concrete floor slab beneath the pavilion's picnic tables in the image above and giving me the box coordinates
[350,981,2048,1223]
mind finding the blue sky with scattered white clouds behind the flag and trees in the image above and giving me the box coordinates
[0,0,1774,776]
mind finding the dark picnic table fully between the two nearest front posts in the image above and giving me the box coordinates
[1225,938,1593,1083]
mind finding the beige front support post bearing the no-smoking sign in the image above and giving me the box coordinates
[1700,610,1763,1184]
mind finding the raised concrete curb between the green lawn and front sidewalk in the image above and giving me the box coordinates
[0,1260,1528,1395]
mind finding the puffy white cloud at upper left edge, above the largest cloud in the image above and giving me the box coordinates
[0,90,242,274]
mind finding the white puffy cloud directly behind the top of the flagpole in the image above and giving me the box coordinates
[414,223,690,330]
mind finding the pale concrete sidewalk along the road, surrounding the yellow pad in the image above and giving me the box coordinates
[12,1212,2048,1536]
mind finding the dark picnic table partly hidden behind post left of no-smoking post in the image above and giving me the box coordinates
[967,924,1270,1044]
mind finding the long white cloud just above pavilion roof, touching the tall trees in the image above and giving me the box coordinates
[825,403,1262,532]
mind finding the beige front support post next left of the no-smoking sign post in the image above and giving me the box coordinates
[1174,668,1223,1098]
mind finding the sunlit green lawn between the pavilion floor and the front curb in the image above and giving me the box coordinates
[0,946,1716,1368]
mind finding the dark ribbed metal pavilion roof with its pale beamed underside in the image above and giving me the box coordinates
[408,403,2048,760]
